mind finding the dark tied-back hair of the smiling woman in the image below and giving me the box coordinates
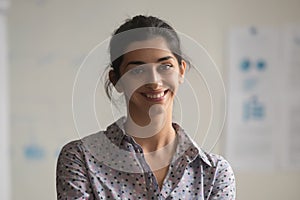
[105,15,183,99]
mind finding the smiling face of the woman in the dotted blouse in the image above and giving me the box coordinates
[118,37,186,122]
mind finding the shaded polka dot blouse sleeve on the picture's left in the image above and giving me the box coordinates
[56,142,94,200]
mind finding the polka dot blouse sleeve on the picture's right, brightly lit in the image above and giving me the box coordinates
[209,156,236,200]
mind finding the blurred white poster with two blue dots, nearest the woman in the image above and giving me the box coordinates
[226,27,282,169]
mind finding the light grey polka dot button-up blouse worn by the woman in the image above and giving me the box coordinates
[56,119,235,200]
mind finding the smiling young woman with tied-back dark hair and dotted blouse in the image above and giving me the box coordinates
[56,15,235,199]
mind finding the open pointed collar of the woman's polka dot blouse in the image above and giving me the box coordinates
[106,117,212,166]
